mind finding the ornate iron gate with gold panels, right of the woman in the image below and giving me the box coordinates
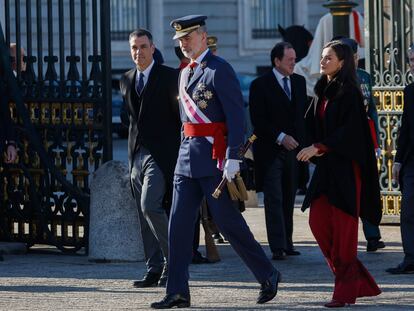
[365,0,414,221]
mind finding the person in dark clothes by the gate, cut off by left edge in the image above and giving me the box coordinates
[0,60,17,261]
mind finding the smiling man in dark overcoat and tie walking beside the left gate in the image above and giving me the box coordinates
[120,29,181,287]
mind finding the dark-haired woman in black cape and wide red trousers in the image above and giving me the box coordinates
[297,41,381,308]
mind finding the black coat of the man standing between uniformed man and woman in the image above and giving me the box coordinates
[249,71,307,191]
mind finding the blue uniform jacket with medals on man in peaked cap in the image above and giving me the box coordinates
[175,52,245,178]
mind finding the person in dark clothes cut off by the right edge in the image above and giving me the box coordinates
[387,45,414,274]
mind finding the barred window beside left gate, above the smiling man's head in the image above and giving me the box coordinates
[111,0,148,41]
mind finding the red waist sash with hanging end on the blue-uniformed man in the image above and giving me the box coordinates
[184,122,227,160]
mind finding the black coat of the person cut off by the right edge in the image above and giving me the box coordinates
[395,83,414,187]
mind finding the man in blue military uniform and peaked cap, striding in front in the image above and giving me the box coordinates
[151,15,280,309]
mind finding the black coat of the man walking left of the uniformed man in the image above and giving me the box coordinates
[120,63,181,187]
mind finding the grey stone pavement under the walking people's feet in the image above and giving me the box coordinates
[0,207,414,311]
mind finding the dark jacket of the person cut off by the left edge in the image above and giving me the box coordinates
[0,78,15,155]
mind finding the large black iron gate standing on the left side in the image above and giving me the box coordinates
[0,0,112,252]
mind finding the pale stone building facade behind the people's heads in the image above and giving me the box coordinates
[111,0,336,74]
